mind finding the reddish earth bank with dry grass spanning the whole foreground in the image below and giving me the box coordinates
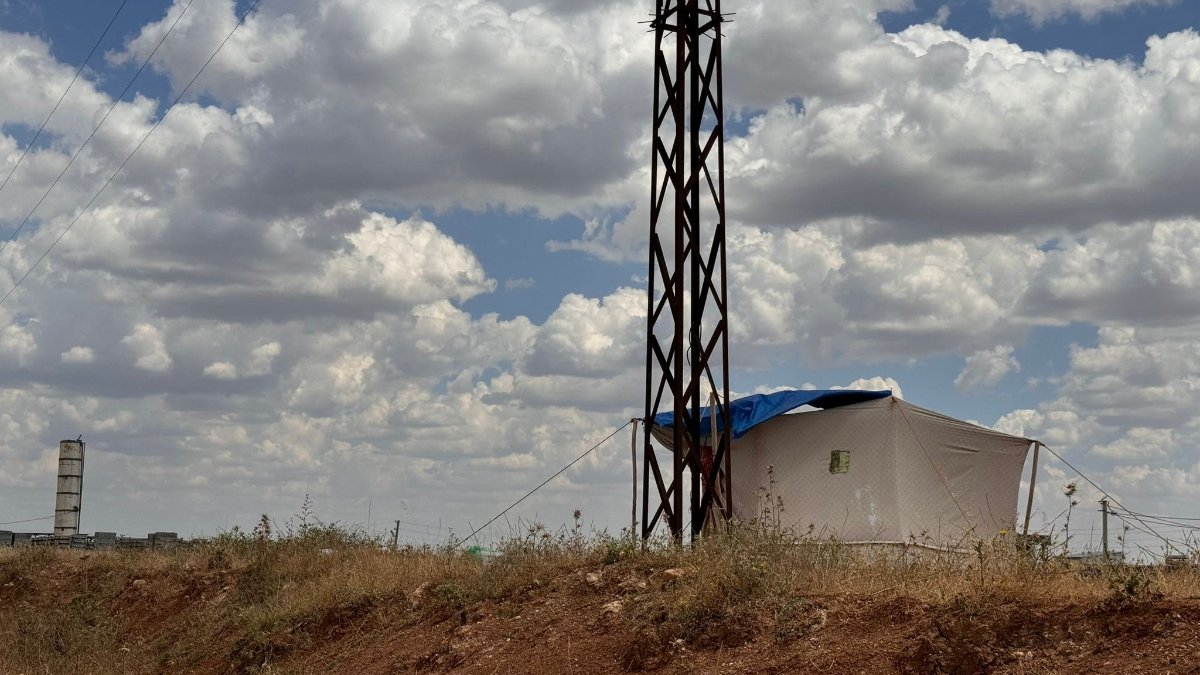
[0,546,1200,675]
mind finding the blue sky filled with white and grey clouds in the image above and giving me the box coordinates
[0,0,1200,557]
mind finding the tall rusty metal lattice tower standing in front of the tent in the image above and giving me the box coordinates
[642,0,732,539]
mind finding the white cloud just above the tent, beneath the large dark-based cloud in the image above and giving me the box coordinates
[730,223,1044,363]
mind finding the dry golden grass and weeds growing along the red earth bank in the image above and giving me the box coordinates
[0,527,1200,674]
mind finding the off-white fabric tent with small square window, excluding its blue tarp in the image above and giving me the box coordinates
[655,392,1034,548]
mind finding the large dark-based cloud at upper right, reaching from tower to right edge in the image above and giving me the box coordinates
[728,19,1200,238]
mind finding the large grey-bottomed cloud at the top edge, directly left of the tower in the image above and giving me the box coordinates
[108,0,649,210]
